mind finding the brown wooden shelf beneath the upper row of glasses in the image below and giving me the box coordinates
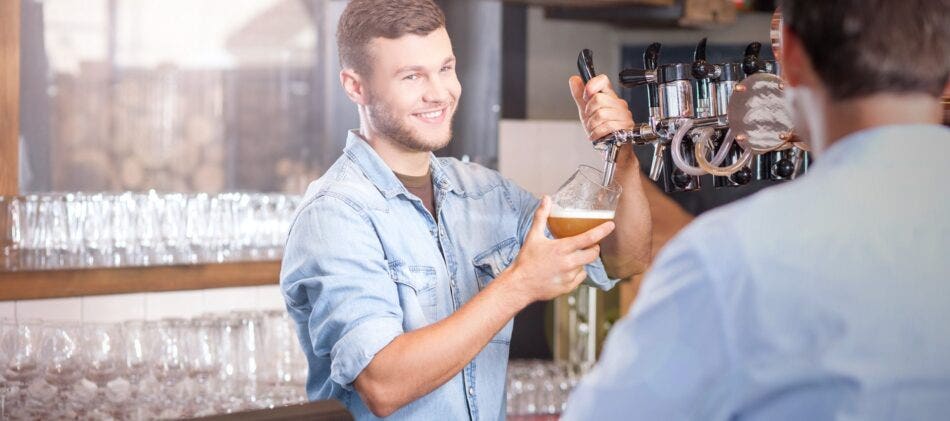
[0,261,280,301]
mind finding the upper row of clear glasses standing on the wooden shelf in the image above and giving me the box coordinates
[0,191,300,271]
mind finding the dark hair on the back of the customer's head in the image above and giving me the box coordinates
[781,0,950,100]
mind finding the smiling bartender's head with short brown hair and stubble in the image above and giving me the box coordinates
[337,0,461,151]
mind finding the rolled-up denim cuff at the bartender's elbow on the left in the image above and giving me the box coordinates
[330,317,403,390]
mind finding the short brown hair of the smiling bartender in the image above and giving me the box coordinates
[336,0,445,73]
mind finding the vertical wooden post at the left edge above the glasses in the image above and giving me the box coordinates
[0,0,20,195]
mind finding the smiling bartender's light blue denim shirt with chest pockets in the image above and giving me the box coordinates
[280,132,616,420]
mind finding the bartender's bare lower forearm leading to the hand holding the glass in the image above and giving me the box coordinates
[354,272,530,416]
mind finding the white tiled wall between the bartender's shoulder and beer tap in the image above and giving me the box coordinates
[498,118,604,197]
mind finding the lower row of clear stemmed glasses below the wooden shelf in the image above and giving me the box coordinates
[0,311,307,420]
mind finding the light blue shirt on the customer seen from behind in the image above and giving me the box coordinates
[564,126,950,421]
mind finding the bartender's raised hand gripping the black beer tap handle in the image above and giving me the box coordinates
[568,75,634,141]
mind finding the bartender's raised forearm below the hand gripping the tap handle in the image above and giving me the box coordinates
[600,146,653,279]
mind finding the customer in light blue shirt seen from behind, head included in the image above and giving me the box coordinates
[564,0,950,421]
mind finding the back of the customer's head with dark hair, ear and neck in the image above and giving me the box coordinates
[781,0,950,154]
